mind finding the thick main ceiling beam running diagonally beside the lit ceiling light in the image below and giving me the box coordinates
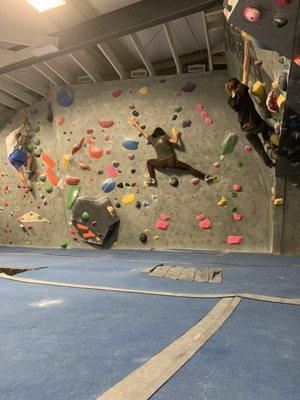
[0,0,223,74]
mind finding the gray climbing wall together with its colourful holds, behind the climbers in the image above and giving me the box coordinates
[1,71,272,252]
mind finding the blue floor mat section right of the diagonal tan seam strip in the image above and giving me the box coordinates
[151,300,300,400]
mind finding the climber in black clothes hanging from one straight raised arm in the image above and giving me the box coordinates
[225,39,274,168]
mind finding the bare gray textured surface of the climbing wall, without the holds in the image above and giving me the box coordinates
[0,71,272,252]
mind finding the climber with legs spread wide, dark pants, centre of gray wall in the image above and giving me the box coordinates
[130,118,218,186]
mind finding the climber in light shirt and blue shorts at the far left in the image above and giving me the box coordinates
[5,123,32,192]
